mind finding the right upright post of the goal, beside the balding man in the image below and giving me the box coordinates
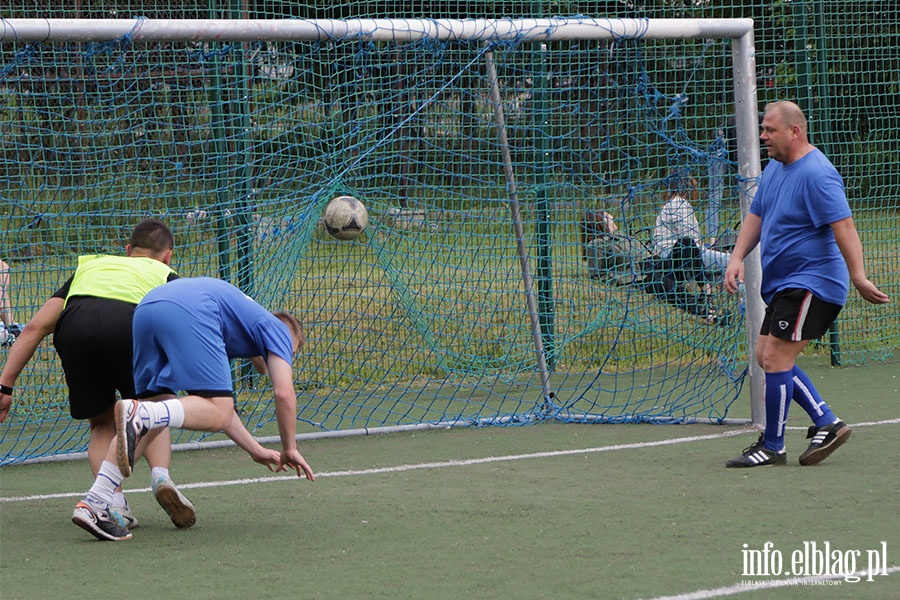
[731,29,766,425]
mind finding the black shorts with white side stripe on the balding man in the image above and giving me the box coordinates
[759,288,843,342]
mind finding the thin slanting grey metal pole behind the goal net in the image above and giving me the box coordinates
[484,50,554,410]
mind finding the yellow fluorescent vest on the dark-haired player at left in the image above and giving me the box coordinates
[66,254,174,304]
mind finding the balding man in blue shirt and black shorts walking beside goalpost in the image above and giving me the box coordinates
[725,102,888,467]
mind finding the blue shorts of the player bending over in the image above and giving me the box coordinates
[133,302,234,398]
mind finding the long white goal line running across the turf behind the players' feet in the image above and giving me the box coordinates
[0,419,900,503]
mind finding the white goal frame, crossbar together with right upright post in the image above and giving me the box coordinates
[0,17,765,425]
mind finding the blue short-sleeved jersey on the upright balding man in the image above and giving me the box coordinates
[750,148,851,306]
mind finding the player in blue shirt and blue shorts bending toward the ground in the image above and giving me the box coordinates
[72,277,314,541]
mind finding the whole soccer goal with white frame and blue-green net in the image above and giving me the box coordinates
[0,17,762,464]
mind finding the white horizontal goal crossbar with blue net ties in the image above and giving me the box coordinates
[0,17,753,43]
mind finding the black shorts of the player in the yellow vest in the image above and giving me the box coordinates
[53,297,134,419]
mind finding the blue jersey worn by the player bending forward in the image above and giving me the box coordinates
[140,277,294,364]
